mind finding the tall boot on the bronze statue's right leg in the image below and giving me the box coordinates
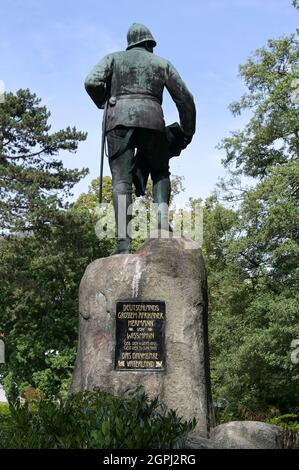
[153,177,172,232]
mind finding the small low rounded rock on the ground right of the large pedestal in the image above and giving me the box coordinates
[211,421,286,449]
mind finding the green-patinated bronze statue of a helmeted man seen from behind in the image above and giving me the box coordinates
[85,23,196,254]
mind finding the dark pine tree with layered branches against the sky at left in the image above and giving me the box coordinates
[0,90,87,233]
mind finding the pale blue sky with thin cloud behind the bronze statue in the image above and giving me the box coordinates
[0,0,299,204]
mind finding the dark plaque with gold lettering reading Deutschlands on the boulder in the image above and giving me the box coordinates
[115,301,166,371]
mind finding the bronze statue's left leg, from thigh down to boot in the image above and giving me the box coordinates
[108,129,134,255]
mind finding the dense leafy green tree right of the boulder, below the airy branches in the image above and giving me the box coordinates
[209,180,299,413]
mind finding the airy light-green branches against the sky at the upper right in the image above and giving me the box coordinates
[220,34,299,178]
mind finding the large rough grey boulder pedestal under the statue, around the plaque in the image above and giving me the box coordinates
[71,238,213,437]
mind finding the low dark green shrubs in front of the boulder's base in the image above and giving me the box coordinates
[0,390,196,449]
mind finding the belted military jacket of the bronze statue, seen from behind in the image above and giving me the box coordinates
[85,47,196,136]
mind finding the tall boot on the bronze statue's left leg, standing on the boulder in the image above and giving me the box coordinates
[111,192,132,255]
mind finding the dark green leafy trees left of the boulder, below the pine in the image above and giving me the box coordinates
[0,209,112,399]
